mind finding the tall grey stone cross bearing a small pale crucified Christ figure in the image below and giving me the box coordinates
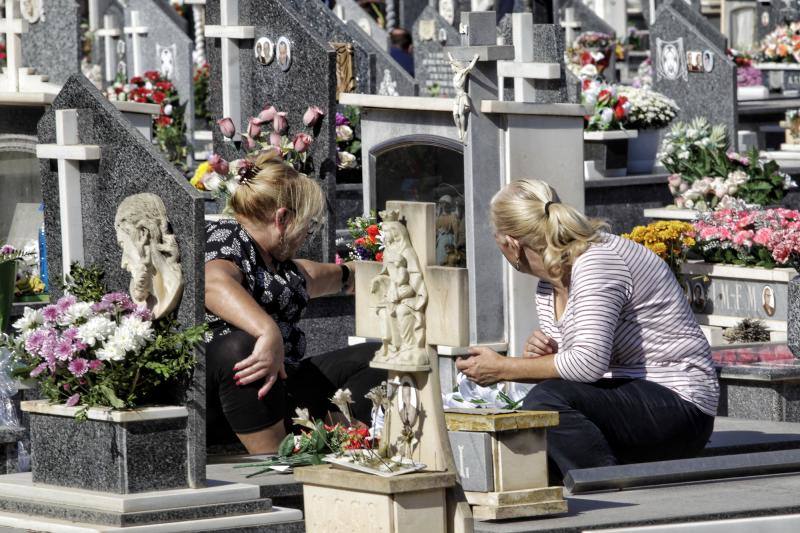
[447,11,514,345]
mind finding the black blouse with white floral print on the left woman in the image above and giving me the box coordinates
[205,219,308,363]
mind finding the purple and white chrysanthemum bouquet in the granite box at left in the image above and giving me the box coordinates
[0,265,206,418]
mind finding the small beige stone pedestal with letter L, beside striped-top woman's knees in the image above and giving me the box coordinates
[445,409,567,520]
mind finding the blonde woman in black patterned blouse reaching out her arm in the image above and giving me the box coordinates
[205,150,386,453]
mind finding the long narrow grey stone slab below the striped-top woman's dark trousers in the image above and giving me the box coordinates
[564,450,800,494]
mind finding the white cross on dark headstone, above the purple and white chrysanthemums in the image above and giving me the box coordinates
[36,109,100,276]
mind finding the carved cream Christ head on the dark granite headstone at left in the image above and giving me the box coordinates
[114,193,184,318]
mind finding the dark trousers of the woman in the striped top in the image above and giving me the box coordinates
[523,379,714,484]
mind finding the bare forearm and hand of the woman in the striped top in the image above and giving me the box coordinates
[456,347,560,386]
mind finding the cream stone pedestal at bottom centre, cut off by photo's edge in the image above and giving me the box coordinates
[294,466,456,533]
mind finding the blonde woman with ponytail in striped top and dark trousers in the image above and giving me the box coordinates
[457,179,719,474]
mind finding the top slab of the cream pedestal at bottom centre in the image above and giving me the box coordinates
[294,465,456,494]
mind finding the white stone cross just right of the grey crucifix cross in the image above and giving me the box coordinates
[497,13,561,102]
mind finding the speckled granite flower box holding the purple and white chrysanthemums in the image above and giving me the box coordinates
[21,400,189,494]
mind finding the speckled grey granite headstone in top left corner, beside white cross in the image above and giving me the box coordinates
[22,0,81,85]
